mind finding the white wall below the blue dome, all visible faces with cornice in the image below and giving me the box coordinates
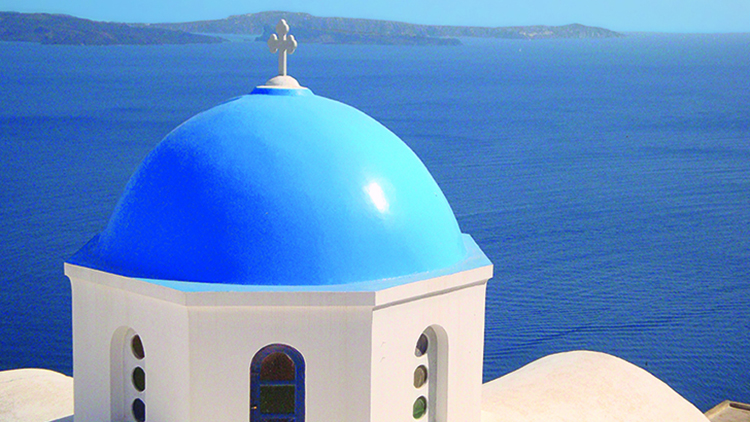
[66,254,492,422]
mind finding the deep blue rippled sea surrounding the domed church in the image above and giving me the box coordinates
[0,34,750,411]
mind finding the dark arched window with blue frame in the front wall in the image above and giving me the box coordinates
[250,344,305,422]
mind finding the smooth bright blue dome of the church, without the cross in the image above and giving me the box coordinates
[70,88,466,286]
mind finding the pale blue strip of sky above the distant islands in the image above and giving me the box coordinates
[0,0,750,32]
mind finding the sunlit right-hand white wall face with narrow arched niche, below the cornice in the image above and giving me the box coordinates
[371,280,486,422]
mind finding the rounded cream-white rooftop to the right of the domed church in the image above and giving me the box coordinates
[482,351,708,422]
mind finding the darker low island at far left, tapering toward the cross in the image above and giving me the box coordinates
[0,12,226,45]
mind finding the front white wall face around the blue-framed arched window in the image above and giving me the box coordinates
[189,306,371,422]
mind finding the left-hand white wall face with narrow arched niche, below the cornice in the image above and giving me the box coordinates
[71,273,190,422]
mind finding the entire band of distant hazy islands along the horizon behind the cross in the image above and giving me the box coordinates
[0,12,623,46]
